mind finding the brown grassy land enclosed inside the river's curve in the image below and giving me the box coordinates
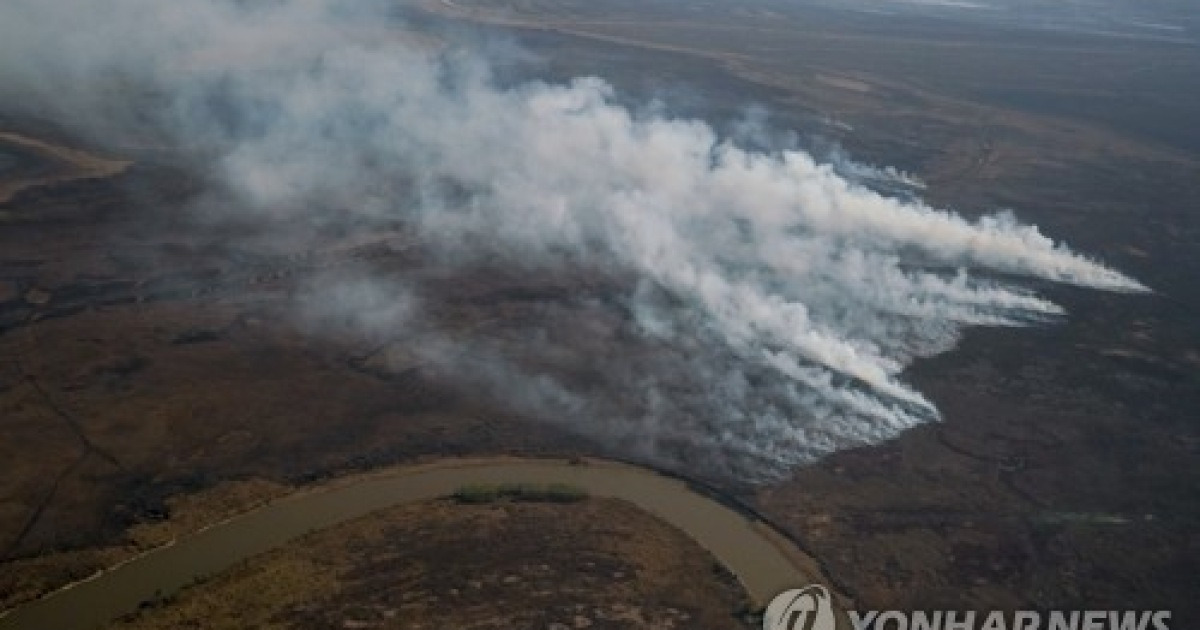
[109,498,752,630]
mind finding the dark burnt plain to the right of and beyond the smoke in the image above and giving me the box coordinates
[405,0,1200,619]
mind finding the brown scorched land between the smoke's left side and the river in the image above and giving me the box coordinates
[0,146,592,604]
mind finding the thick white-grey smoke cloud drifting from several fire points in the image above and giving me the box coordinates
[0,0,1144,475]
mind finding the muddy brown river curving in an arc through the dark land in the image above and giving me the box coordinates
[0,460,818,630]
